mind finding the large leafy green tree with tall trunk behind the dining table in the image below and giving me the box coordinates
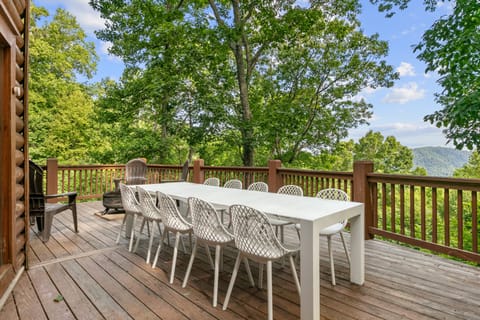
[90,0,397,165]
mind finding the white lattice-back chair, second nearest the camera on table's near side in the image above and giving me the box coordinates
[182,198,255,307]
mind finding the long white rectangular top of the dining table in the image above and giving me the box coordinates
[140,182,363,226]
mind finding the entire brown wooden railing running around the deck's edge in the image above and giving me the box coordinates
[42,159,480,264]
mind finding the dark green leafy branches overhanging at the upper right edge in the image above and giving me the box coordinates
[370,0,480,150]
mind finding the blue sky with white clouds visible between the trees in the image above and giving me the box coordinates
[33,0,452,148]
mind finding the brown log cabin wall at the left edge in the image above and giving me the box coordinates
[0,0,30,297]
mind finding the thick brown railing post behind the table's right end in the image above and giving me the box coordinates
[353,161,374,240]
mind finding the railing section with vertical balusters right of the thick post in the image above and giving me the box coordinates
[367,173,480,263]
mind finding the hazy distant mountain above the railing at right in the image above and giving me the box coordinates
[412,147,471,177]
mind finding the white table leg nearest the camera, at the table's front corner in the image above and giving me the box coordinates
[300,221,320,320]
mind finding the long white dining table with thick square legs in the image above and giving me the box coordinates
[140,182,365,320]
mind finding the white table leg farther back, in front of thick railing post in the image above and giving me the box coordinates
[350,208,365,285]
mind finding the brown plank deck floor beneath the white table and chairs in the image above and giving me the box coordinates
[0,202,480,320]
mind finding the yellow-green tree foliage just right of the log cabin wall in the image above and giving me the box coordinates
[29,5,98,163]
